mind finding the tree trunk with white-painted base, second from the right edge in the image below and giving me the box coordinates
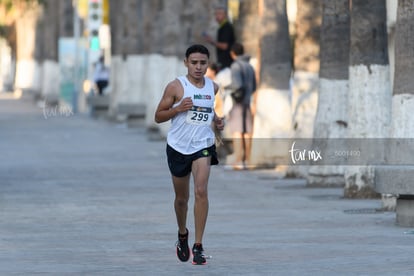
[344,0,391,198]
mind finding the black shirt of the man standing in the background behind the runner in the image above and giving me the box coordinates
[217,21,236,68]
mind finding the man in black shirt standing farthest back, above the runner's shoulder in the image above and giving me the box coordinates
[204,7,236,70]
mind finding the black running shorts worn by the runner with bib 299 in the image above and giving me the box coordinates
[167,144,218,177]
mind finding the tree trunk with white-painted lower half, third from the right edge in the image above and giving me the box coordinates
[307,0,350,186]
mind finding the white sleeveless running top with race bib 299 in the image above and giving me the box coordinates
[167,76,215,154]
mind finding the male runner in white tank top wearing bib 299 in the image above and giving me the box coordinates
[155,45,224,265]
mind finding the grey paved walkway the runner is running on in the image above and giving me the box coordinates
[0,95,414,275]
